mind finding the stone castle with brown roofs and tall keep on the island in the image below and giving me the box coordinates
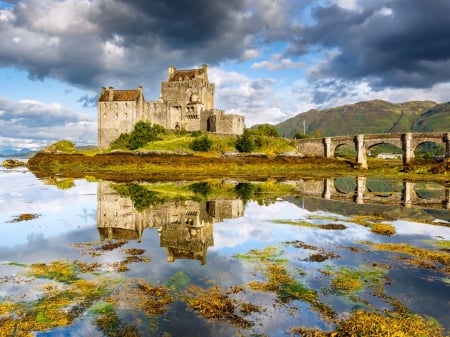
[97,64,245,149]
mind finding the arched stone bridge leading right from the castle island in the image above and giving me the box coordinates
[296,132,450,168]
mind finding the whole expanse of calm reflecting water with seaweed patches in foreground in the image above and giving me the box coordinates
[0,164,450,336]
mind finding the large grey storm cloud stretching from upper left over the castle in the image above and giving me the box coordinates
[0,0,284,95]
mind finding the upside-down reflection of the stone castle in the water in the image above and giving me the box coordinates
[97,182,244,264]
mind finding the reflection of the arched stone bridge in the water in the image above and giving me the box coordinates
[297,176,450,209]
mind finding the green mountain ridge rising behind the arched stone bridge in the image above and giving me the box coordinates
[268,100,450,138]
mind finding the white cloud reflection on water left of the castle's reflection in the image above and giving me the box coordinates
[0,171,96,247]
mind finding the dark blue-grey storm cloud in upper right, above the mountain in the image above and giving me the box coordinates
[289,0,450,89]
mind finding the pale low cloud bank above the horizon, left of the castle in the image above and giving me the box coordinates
[0,98,97,148]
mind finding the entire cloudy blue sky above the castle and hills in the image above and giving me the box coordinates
[0,0,450,150]
